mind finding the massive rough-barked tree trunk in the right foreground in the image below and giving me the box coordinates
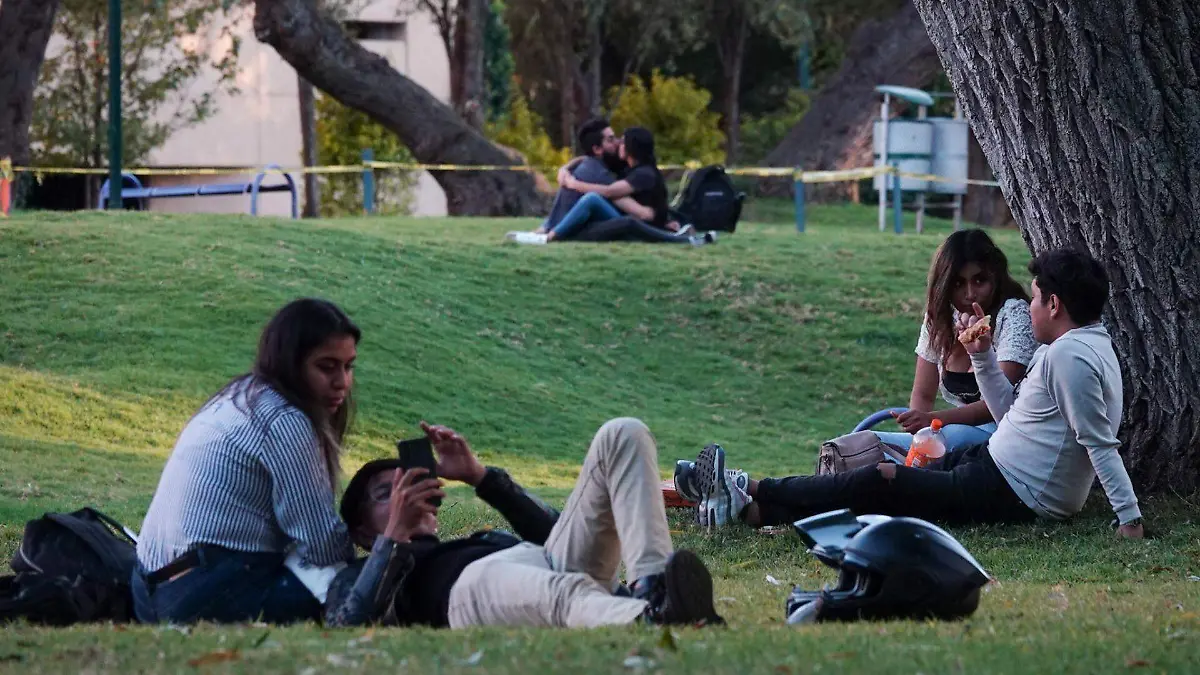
[917,0,1200,490]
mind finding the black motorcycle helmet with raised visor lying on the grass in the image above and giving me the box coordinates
[787,509,989,623]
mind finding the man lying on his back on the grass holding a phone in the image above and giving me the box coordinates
[325,418,721,628]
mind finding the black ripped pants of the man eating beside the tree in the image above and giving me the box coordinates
[755,446,1037,525]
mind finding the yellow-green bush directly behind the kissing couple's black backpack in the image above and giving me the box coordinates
[608,70,725,165]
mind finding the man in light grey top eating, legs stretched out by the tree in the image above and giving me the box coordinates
[691,250,1142,538]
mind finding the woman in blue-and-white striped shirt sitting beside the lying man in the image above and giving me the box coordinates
[133,299,360,623]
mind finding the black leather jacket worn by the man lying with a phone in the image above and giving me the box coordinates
[325,467,558,627]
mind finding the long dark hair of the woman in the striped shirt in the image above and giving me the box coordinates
[202,298,362,490]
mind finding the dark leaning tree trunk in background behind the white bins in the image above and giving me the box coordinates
[764,2,941,199]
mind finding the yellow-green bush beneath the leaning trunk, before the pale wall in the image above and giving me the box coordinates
[317,95,418,216]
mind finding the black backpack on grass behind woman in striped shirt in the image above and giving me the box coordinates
[0,508,137,626]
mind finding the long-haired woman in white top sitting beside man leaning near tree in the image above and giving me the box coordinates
[876,229,1038,449]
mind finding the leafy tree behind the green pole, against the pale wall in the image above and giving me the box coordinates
[28,0,239,203]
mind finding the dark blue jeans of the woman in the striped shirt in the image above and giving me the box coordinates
[132,546,322,623]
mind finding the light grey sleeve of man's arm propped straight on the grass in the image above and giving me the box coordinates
[1046,345,1141,524]
